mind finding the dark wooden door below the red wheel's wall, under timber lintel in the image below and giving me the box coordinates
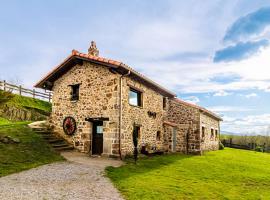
[92,121,103,155]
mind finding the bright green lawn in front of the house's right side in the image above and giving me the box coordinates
[106,148,270,200]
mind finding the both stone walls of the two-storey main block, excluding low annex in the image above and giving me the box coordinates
[50,62,166,156]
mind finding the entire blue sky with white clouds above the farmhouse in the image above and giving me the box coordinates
[0,0,270,134]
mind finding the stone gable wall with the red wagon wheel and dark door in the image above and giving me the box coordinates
[50,62,120,155]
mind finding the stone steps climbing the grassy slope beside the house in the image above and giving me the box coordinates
[30,124,74,151]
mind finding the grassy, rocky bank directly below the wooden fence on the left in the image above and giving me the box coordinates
[0,91,51,124]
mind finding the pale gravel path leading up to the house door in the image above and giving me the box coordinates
[0,152,122,200]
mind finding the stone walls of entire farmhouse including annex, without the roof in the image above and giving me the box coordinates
[39,42,220,157]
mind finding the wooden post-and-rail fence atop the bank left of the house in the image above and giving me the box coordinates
[0,81,52,102]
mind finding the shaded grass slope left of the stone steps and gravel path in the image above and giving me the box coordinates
[0,122,64,177]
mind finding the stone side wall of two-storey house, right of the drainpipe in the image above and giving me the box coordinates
[121,77,166,155]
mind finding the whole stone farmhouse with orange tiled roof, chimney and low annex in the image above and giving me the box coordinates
[35,42,222,158]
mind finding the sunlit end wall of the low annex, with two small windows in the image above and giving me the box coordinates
[200,113,220,151]
